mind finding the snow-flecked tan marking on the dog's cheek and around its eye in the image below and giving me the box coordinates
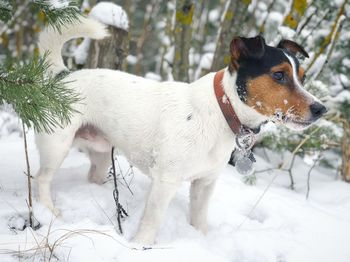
[247,71,310,119]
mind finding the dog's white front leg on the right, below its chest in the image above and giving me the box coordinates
[190,178,216,234]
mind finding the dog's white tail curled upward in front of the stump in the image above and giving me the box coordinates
[38,17,108,75]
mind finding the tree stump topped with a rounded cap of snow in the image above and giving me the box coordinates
[84,2,129,69]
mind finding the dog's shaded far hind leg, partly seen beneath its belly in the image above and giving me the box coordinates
[88,151,112,185]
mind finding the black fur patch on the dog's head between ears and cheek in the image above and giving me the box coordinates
[236,45,299,102]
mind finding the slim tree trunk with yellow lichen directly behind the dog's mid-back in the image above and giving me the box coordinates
[173,0,194,82]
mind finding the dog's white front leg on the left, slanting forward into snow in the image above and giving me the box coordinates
[133,178,180,245]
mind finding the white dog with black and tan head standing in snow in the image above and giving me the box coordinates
[36,18,326,244]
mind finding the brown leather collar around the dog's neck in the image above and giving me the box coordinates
[214,69,248,135]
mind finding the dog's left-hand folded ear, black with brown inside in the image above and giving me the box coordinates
[230,35,266,62]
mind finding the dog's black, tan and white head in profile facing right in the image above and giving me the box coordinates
[229,36,327,129]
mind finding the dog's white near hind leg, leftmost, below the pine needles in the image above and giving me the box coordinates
[36,130,74,216]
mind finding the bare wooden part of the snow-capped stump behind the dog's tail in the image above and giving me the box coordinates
[84,26,128,69]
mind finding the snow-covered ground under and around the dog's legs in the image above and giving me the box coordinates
[0,132,350,262]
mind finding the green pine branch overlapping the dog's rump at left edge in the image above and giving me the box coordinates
[0,55,79,132]
